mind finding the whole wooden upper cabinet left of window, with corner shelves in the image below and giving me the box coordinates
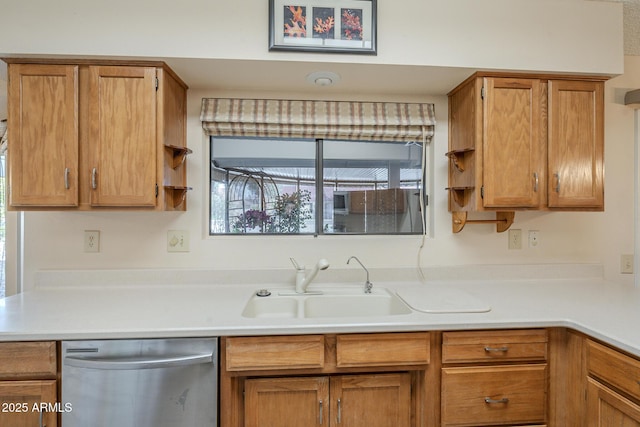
[4,58,191,210]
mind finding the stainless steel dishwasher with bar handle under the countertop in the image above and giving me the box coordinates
[62,338,218,427]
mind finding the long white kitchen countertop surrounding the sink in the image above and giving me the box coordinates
[0,268,640,357]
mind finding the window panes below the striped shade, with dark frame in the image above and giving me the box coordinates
[210,136,426,234]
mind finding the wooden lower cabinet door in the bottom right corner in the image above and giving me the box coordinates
[587,378,640,427]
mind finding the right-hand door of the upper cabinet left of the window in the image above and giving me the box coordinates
[87,66,157,207]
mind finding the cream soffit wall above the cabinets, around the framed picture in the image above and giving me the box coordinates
[0,0,623,74]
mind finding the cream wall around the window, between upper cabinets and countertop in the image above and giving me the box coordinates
[12,57,640,294]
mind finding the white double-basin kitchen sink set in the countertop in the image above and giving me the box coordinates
[242,287,412,318]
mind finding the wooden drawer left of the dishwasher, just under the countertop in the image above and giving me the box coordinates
[0,341,57,380]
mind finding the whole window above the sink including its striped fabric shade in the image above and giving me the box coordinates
[200,98,435,234]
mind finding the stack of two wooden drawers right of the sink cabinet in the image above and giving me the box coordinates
[440,329,549,427]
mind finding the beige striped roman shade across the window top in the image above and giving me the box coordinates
[200,98,435,142]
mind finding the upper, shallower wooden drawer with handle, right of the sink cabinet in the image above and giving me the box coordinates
[442,329,548,363]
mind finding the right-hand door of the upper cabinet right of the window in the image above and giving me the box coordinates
[548,80,604,209]
